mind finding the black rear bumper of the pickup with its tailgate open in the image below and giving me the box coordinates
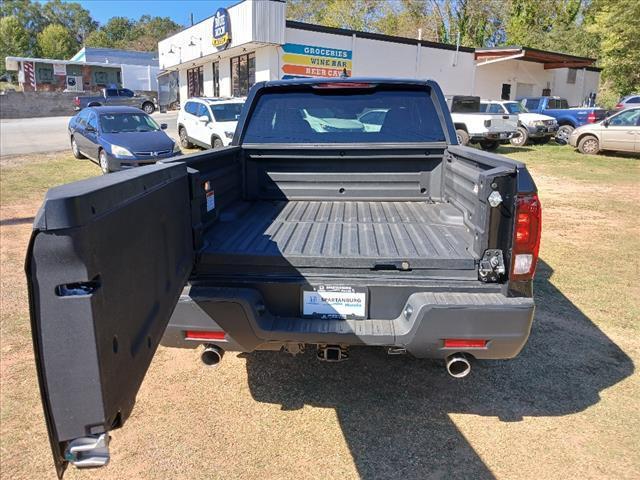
[162,287,534,359]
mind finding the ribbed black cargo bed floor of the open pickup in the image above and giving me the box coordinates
[201,201,475,270]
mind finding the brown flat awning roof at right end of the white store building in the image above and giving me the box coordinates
[475,47,596,70]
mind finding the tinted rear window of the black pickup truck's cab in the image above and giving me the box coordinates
[244,87,445,143]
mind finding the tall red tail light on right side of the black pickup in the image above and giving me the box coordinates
[510,193,542,281]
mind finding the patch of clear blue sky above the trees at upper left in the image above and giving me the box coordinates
[54,0,238,25]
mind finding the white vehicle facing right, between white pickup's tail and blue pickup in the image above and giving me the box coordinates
[480,100,558,147]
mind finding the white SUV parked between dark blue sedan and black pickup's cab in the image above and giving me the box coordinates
[178,98,245,148]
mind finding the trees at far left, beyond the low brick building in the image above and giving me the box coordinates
[0,0,183,73]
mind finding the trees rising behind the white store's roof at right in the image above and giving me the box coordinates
[287,0,640,106]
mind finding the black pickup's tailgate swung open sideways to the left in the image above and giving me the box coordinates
[26,163,194,477]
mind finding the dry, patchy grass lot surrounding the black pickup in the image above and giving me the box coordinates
[0,145,640,479]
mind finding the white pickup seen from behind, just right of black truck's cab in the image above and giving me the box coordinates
[446,95,518,151]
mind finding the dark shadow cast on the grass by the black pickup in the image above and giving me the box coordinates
[244,262,634,479]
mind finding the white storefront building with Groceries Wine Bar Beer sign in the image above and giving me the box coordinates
[158,0,597,104]
